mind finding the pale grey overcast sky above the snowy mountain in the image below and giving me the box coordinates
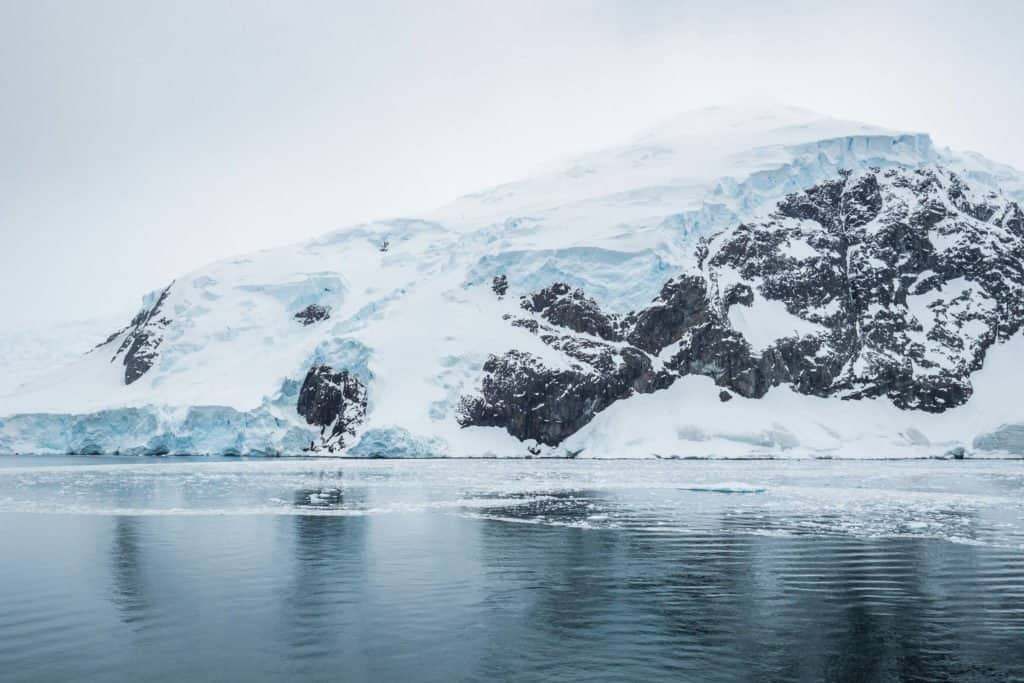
[6,0,1024,332]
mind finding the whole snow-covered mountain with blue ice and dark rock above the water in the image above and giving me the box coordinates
[0,108,1024,457]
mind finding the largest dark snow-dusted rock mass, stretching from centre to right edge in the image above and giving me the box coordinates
[460,168,1024,445]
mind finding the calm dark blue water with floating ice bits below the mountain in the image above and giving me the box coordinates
[0,457,1024,681]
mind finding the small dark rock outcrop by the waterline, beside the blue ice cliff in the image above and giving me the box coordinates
[297,366,367,452]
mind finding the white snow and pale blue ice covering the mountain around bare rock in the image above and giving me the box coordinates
[0,108,1024,457]
